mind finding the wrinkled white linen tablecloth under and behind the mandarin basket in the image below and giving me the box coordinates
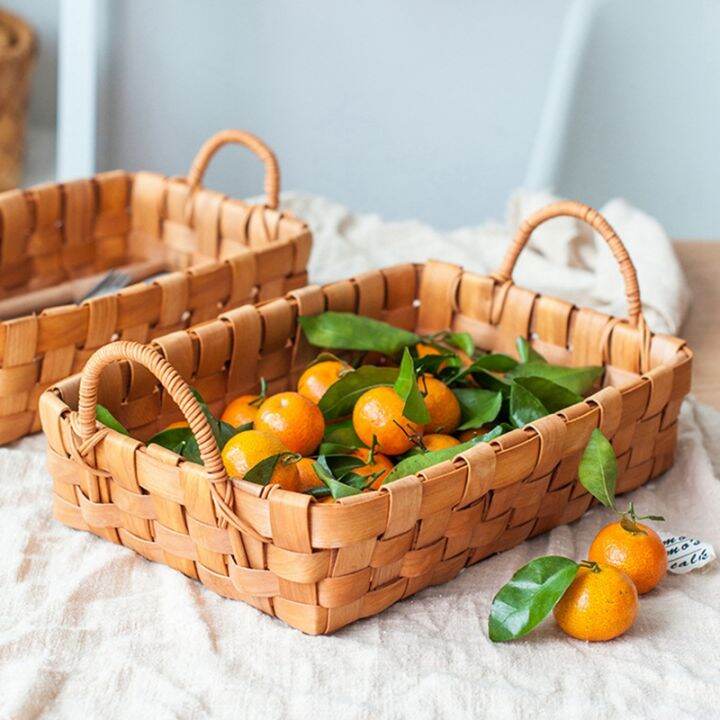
[0,194,720,720]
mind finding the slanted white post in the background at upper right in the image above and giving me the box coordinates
[523,0,601,191]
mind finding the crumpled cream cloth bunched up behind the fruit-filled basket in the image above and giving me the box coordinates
[284,191,690,332]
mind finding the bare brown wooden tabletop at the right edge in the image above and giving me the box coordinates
[675,241,720,410]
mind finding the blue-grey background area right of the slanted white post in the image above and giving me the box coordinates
[558,0,720,240]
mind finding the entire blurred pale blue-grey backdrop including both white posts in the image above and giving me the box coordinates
[2,0,720,239]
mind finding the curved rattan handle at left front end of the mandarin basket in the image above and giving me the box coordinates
[78,340,228,483]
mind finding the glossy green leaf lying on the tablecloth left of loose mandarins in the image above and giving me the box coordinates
[489,555,580,642]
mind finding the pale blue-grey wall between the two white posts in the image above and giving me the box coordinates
[101,0,568,227]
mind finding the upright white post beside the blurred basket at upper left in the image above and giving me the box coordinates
[57,0,99,180]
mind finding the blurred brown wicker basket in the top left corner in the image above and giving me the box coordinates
[0,10,37,190]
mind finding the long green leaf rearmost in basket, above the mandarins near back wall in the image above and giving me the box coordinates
[299,311,420,356]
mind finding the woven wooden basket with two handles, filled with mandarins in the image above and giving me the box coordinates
[40,202,692,634]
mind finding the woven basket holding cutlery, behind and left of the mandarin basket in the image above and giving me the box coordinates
[0,130,311,444]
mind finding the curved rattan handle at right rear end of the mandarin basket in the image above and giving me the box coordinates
[493,200,644,327]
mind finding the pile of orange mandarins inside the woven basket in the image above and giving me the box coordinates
[221,345,466,501]
